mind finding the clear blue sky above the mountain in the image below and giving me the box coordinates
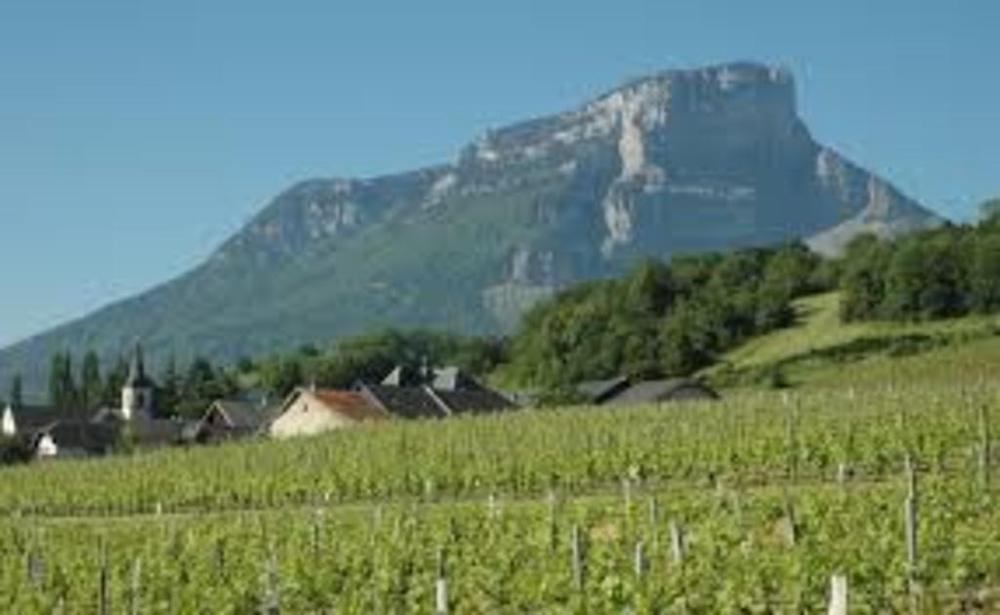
[0,0,1000,344]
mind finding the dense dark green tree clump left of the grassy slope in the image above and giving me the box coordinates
[506,244,819,388]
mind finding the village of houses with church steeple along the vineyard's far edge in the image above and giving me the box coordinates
[0,345,718,461]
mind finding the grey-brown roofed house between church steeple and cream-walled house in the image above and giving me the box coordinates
[183,396,282,443]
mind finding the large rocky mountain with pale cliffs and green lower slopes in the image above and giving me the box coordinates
[0,63,939,390]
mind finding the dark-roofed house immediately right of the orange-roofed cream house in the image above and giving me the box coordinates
[355,366,516,419]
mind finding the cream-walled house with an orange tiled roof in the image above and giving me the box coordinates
[267,387,390,438]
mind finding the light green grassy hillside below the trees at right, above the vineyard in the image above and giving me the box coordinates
[703,293,1000,388]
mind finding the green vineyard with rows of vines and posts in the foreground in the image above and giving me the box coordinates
[0,380,1000,613]
